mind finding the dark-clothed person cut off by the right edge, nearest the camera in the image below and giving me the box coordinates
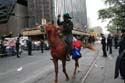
[115,29,125,83]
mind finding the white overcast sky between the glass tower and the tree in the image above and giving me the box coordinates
[86,0,107,33]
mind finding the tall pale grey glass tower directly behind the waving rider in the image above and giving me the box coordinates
[54,0,87,31]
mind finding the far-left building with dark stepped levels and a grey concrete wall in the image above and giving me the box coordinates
[0,0,28,36]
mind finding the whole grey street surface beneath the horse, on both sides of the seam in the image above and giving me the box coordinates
[0,44,122,83]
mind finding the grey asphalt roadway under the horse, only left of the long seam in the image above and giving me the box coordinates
[0,46,96,83]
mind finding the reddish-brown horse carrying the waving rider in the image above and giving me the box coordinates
[45,24,79,83]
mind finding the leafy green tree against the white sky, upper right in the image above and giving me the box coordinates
[98,0,125,30]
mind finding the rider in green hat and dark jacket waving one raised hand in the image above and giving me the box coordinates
[57,13,73,60]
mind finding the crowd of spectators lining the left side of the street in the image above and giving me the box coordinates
[0,36,46,58]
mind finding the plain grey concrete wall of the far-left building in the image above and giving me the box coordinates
[7,3,28,36]
